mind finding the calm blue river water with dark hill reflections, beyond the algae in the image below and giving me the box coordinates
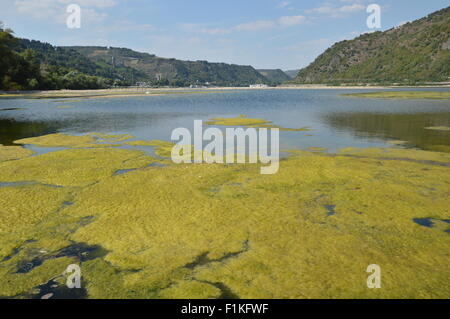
[0,89,450,155]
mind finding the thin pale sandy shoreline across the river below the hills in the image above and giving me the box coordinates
[0,84,450,99]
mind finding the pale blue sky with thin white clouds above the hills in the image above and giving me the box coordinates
[0,0,449,70]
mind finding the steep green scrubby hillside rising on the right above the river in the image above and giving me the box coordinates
[294,7,450,84]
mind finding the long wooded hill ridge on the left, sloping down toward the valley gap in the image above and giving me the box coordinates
[0,23,271,90]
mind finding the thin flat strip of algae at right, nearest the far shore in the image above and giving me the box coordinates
[342,91,450,100]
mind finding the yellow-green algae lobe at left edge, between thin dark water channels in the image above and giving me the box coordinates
[0,148,154,186]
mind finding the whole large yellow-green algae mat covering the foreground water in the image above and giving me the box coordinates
[0,134,450,299]
